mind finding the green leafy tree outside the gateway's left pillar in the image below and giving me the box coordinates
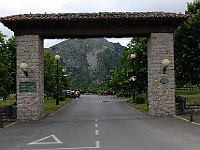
[0,32,16,99]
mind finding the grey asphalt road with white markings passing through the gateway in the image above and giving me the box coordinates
[0,95,200,150]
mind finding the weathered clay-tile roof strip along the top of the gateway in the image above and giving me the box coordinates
[0,12,188,22]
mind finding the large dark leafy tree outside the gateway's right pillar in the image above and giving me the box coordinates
[174,0,200,86]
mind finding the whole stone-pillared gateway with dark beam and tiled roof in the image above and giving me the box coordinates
[0,12,187,121]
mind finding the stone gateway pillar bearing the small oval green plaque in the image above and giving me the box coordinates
[147,33,175,116]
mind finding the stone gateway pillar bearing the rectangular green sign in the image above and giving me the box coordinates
[16,35,44,121]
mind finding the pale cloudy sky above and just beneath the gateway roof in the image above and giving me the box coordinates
[0,0,193,48]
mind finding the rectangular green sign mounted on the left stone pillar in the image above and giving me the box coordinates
[19,82,37,93]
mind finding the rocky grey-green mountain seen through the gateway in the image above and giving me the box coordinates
[47,38,124,90]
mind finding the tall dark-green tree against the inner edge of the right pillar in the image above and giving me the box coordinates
[121,38,148,93]
